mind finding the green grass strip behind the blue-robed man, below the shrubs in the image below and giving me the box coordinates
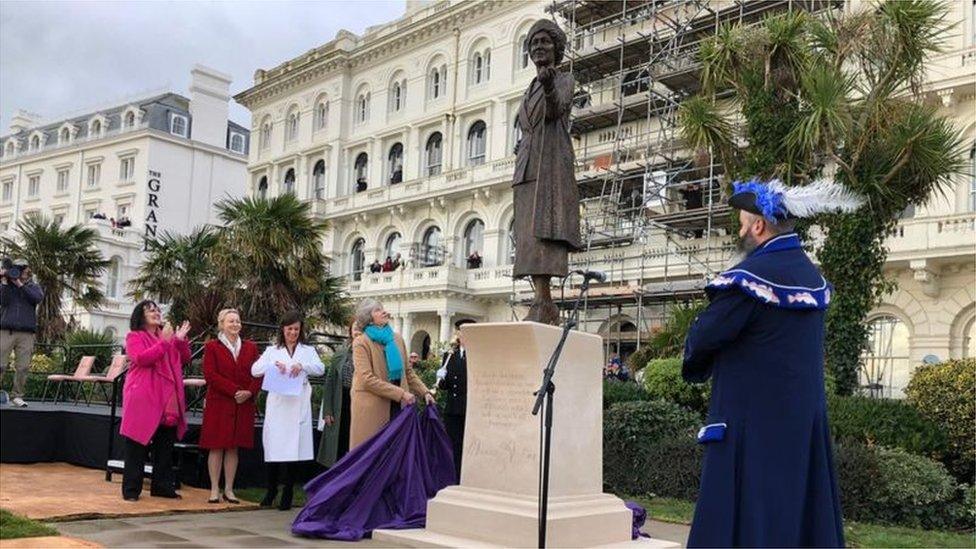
[621,496,976,549]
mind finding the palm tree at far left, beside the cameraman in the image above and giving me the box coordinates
[0,216,109,342]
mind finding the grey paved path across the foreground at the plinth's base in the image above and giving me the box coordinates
[53,510,688,548]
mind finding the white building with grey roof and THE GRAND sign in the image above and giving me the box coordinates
[0,65,250,337]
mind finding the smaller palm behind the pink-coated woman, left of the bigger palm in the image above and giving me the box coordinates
[129,227,221,330]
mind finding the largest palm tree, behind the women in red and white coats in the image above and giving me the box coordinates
[214,193,349,325]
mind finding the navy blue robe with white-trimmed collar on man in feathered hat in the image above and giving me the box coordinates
[683,234,844,547]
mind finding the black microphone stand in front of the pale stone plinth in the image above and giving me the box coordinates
[532,275,590,549]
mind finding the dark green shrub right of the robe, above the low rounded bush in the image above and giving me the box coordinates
[827,396,949,460]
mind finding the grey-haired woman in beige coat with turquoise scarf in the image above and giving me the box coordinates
[349,299,434,451]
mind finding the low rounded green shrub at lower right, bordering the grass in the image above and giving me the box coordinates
[837,443,972,529]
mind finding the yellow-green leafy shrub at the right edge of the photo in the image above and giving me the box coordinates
[905,358,976,484]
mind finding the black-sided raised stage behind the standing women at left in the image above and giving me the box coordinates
[0,401,323,488]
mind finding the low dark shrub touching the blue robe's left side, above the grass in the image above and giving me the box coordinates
[641,436,705,501]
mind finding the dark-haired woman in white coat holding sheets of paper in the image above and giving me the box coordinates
[251,312,325,511]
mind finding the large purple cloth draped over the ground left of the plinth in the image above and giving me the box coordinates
[291,406,457,541]
